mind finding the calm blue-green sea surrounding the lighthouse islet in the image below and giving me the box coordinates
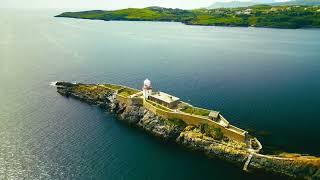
[0,10,320,179]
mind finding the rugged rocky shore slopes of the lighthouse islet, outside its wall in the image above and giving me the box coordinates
[56,82,320,179]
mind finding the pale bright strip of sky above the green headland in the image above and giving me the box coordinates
[0,0,284,10]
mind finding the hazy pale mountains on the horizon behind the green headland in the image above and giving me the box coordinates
[208,0,320,9]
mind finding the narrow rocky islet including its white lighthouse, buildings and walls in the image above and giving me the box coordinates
[55,79,320,179]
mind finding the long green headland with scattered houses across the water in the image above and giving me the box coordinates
[56,5,320,29]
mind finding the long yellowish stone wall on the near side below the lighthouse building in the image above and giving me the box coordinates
[143,101,246,142]
